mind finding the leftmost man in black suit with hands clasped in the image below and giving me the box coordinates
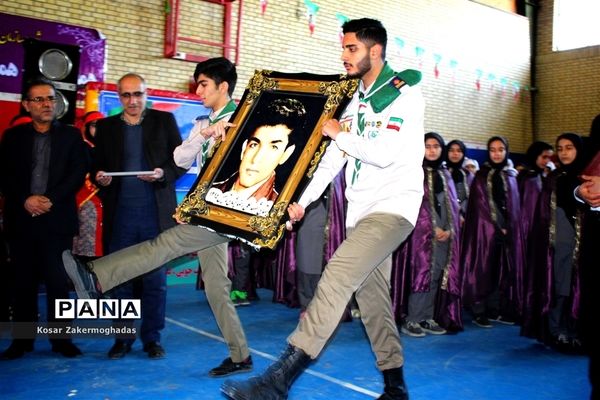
[0,78,87,360]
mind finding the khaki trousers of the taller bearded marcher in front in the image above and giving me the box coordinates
[288,213,413,371]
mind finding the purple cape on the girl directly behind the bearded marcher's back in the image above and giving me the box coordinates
[393,168,463,331]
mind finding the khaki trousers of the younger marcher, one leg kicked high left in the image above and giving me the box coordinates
[90,225,250,362]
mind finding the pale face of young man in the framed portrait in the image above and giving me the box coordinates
[239,124,295,188]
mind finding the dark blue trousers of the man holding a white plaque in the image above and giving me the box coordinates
[109,206,167,344]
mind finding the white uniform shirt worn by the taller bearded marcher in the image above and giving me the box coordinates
[298,75,425,227]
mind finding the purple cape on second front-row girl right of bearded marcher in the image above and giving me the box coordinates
[461,163,524,317]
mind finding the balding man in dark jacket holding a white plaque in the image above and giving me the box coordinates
[92,73,185,359]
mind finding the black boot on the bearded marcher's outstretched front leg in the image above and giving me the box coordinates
[221,345,310,400]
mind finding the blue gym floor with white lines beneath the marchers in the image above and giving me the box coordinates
[0,284,589,400]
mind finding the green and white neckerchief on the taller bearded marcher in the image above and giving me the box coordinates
[352,62,400,184]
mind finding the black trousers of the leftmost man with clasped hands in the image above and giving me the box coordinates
[9,223,73,342]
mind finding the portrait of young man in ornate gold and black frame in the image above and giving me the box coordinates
[177,70,358,249]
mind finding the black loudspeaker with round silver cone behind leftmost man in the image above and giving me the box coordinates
[22,39,81,124]
